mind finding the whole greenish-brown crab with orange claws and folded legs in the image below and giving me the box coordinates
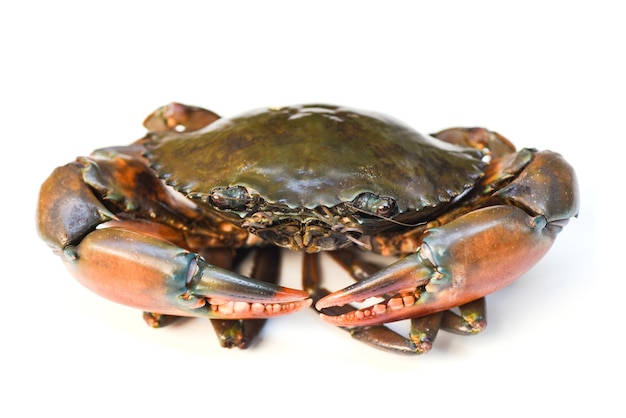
[37,103,579,354]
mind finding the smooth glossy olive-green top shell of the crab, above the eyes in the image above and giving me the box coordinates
[149,104,485,212]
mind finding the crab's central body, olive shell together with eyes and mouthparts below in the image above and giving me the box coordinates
[146,105,489,252]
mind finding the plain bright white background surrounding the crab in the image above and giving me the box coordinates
[0,0,626,417]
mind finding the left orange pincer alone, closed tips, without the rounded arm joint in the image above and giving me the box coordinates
[63,227,311,319]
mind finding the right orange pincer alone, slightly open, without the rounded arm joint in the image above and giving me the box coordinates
[316,205,562,327]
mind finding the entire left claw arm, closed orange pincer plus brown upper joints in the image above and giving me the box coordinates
[37,147,311,319]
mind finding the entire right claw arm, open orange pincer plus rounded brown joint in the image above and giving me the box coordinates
[316,150,579,327]
